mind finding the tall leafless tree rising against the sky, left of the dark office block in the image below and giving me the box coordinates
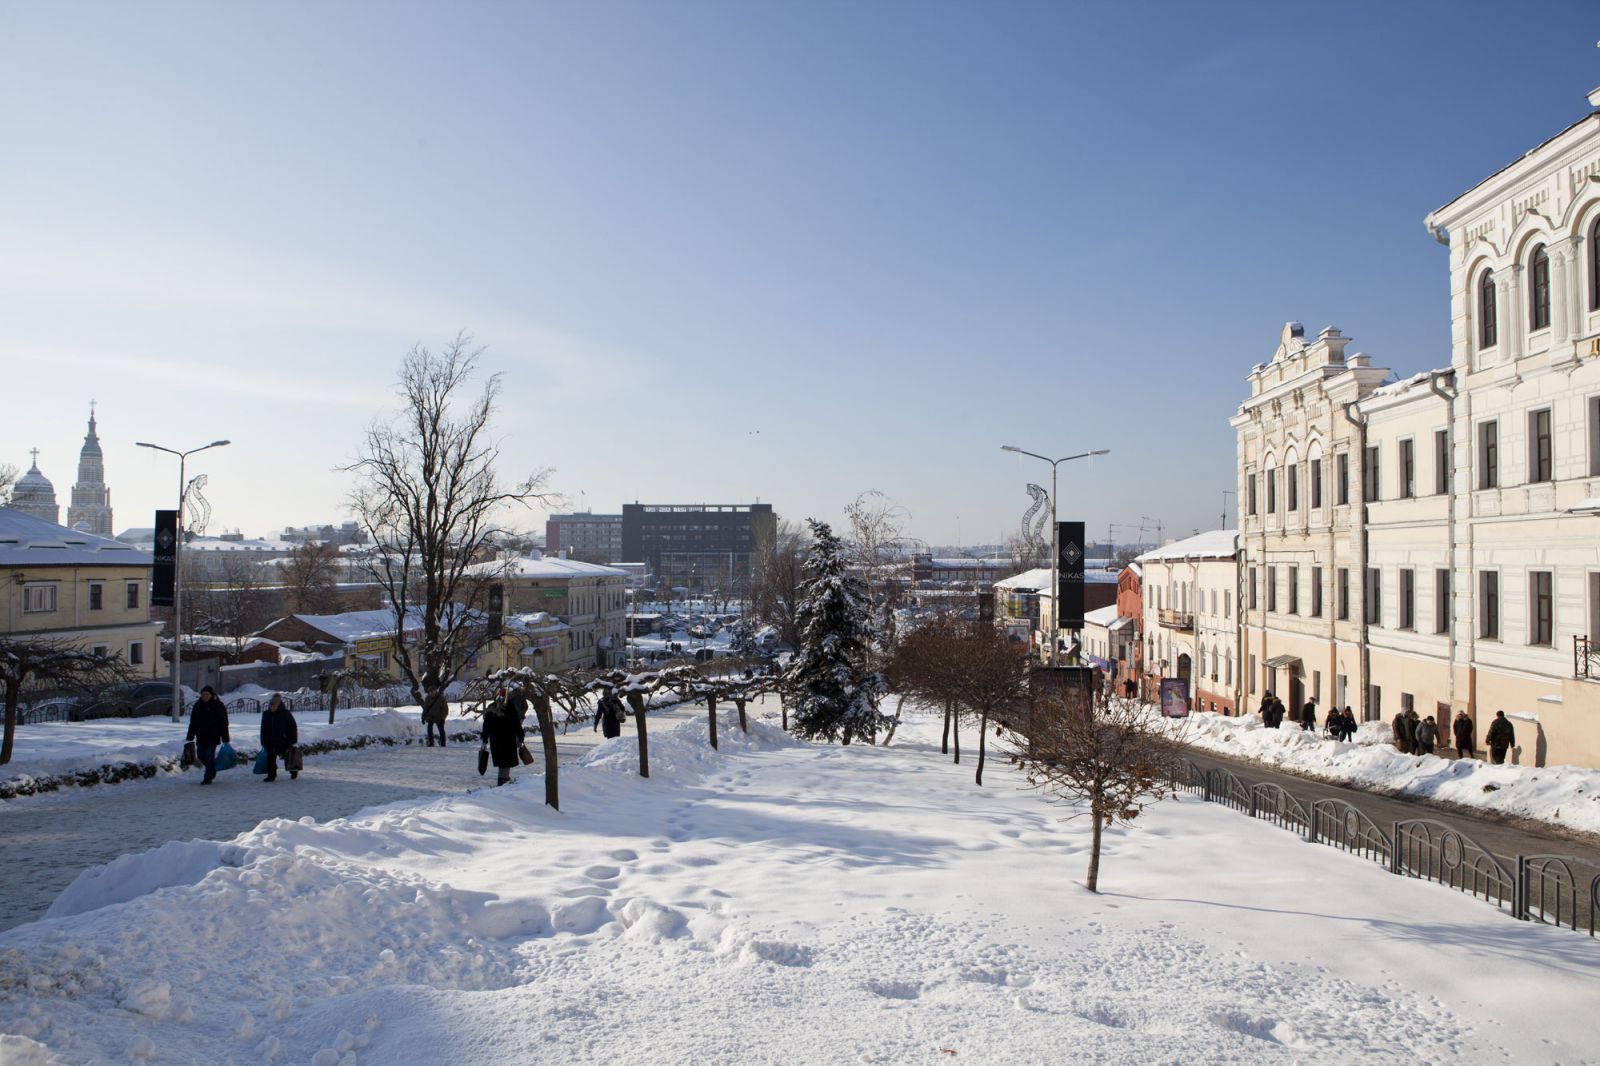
[344,335,550,703]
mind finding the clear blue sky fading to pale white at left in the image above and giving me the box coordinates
[0,0,1600,543]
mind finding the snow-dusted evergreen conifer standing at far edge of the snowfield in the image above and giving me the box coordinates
[784,519,888,744]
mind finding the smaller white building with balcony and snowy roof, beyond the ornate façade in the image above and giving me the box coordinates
[1136,530,1238,714]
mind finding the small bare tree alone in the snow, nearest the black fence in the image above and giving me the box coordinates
[1013,691,1182,892]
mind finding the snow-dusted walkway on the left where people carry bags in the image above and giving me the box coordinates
[0,709,704,928]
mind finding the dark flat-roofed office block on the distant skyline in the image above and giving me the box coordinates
[622,503,778,595]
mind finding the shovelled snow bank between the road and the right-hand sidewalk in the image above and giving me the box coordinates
[1171,707,1600,834]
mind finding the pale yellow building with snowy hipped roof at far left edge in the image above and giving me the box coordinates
[0,507,162,677]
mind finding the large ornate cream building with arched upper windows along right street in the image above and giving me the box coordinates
[1232,93,1600,765]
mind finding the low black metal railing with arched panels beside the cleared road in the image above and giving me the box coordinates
[1170,759,1600,936]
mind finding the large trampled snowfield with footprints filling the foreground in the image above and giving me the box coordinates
[0,694,1600,1066]
